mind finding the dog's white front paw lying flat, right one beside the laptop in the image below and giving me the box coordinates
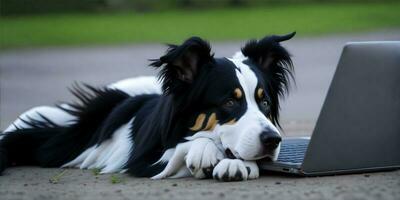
[213,159,259,181]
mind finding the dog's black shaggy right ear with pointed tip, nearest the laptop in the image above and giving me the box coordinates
[242,32,296,126]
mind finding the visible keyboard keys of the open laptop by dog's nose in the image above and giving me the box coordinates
[278,138,310,163]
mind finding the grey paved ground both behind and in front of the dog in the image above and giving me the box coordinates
[0,30,400,200]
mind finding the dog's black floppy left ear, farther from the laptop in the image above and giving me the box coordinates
[150,37,213,93]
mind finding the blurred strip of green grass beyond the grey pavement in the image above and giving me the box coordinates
[0,2,400,49]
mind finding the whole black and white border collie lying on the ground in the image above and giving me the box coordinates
[0,32,295,181]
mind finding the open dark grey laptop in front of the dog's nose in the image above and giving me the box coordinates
[259,41,400,176]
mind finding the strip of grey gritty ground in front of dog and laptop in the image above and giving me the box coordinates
[0,168,400,200]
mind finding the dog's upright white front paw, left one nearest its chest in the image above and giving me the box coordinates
[186,138,224,178]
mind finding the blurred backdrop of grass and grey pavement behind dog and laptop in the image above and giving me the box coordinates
[0,0,400,136]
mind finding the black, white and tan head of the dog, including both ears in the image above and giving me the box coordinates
[151,33,295,160]
